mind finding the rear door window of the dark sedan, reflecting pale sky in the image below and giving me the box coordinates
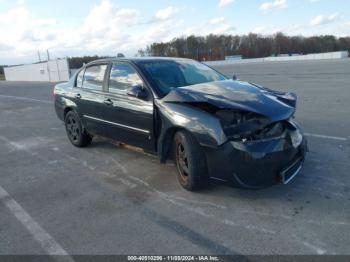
[83,65,107,90]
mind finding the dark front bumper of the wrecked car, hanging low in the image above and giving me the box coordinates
[206,122,307,188]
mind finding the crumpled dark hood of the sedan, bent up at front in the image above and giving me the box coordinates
[162,80,296,121]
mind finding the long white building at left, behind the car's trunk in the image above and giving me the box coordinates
[4,58,70,82]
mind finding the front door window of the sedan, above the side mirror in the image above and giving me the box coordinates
[109,63,142,93]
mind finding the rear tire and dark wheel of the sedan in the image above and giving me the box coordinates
[64,111,92,147]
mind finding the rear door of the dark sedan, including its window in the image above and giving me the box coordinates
[75,64,108,135]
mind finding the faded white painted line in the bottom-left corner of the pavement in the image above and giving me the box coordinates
[0,186,74,261]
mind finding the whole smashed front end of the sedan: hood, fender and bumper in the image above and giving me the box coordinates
[162,81,307,188]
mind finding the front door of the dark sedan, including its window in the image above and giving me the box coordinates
[103,62,155,151]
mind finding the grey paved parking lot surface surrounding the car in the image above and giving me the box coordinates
[0,59,350,255]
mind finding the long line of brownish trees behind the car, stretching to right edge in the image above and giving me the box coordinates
[137,33,350,61]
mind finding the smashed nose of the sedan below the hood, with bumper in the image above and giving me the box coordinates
[211,109,307,188]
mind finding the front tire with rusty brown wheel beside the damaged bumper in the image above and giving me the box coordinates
[174,131,209,191]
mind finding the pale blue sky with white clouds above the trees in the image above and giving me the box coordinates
[0,0,350,64]
